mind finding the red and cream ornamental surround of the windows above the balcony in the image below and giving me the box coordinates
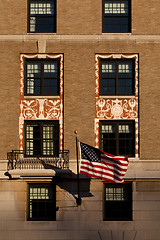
[19,54,63,150]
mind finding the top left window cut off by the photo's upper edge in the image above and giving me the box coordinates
[28,0,56,33]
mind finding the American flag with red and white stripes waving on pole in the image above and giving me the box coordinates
[80,142,129,183]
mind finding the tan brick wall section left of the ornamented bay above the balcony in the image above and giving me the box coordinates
[0,41,36,159]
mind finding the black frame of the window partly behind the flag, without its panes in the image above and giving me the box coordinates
[99,120,135,157]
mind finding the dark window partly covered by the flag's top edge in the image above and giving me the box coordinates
[100,120,135,157]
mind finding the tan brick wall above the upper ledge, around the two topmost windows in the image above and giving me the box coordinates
[0,0,160,35]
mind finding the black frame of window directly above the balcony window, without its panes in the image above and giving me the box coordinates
[24,58,60,96]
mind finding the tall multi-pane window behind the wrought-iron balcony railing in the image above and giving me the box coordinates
[25,120,59,157]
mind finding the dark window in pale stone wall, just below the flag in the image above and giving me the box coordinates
[103,183,132,221]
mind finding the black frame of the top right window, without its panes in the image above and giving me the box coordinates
[102,0,132,34]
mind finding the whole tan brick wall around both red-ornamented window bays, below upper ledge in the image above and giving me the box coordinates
[0,40,160,159]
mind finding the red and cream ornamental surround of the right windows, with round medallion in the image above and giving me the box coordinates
[95,54,139,157]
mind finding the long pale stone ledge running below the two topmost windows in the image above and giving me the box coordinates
[0,33,160,43]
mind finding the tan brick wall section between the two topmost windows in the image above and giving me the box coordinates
[57,0,102,34]
